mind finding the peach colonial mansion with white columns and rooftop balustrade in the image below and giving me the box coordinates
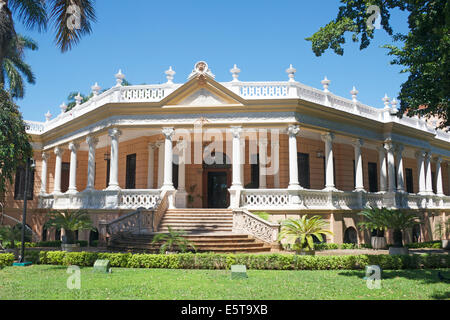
[3,61,450,251]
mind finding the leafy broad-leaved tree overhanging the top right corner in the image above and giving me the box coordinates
[306,0,450,128]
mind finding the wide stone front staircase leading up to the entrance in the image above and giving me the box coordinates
[108,209,271,253]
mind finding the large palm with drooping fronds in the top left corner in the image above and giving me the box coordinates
[0,0,96,88]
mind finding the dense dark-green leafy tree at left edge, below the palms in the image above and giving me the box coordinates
[0,89,32,198]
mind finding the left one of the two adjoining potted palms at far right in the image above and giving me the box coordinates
[358,207,386,249]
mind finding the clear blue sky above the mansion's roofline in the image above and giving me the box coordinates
[16,0,407,121]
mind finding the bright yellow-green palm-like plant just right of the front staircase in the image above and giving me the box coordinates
[278,215,333,255]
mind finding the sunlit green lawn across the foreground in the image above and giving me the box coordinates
[0,265,450,300]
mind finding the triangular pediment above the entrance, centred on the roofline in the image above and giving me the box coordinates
[164,75,244,107]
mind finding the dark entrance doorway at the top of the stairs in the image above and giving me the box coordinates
[205,170,230,208]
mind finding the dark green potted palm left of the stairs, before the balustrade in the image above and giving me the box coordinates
[45,210,94,251]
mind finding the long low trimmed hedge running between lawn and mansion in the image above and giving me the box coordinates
[39,251,450,270]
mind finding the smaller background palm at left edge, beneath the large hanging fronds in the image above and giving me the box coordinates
[0,35,38,98]
